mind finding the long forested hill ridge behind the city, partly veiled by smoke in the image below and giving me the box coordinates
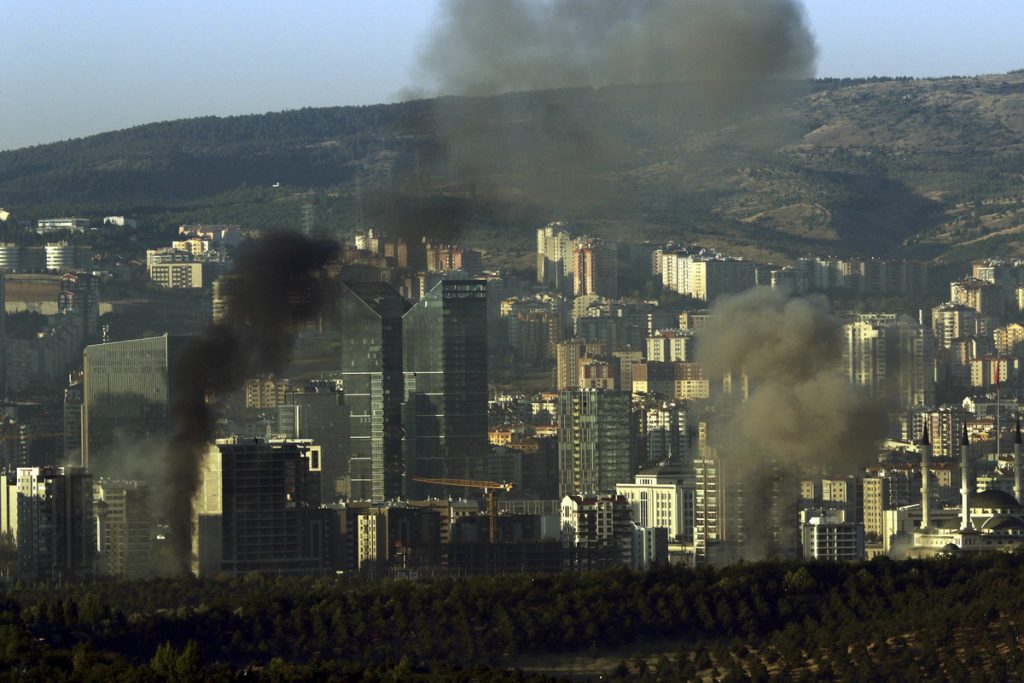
[0,72,1024,260]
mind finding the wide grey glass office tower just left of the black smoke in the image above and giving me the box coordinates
[82,335,187,479]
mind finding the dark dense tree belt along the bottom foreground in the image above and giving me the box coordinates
[0,554,1024,681]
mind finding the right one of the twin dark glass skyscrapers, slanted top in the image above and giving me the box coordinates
[401,280,489,498]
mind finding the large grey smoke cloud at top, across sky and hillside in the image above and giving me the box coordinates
[403,0,816,221]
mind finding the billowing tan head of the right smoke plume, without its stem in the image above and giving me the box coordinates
[697,288,886,471]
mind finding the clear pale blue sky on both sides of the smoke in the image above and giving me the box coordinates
[0,0,1024,150]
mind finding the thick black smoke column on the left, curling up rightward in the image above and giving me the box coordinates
[167,232,338,573]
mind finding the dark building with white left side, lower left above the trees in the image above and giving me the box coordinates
[17,467,96,582]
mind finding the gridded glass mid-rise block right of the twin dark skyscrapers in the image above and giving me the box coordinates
[558,389,633,497]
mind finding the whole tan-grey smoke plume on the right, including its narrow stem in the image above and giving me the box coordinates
[697,288,886,560]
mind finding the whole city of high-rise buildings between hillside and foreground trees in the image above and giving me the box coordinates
[6,215,1024,581]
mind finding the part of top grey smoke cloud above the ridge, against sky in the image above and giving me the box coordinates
[411,0,816,95]
